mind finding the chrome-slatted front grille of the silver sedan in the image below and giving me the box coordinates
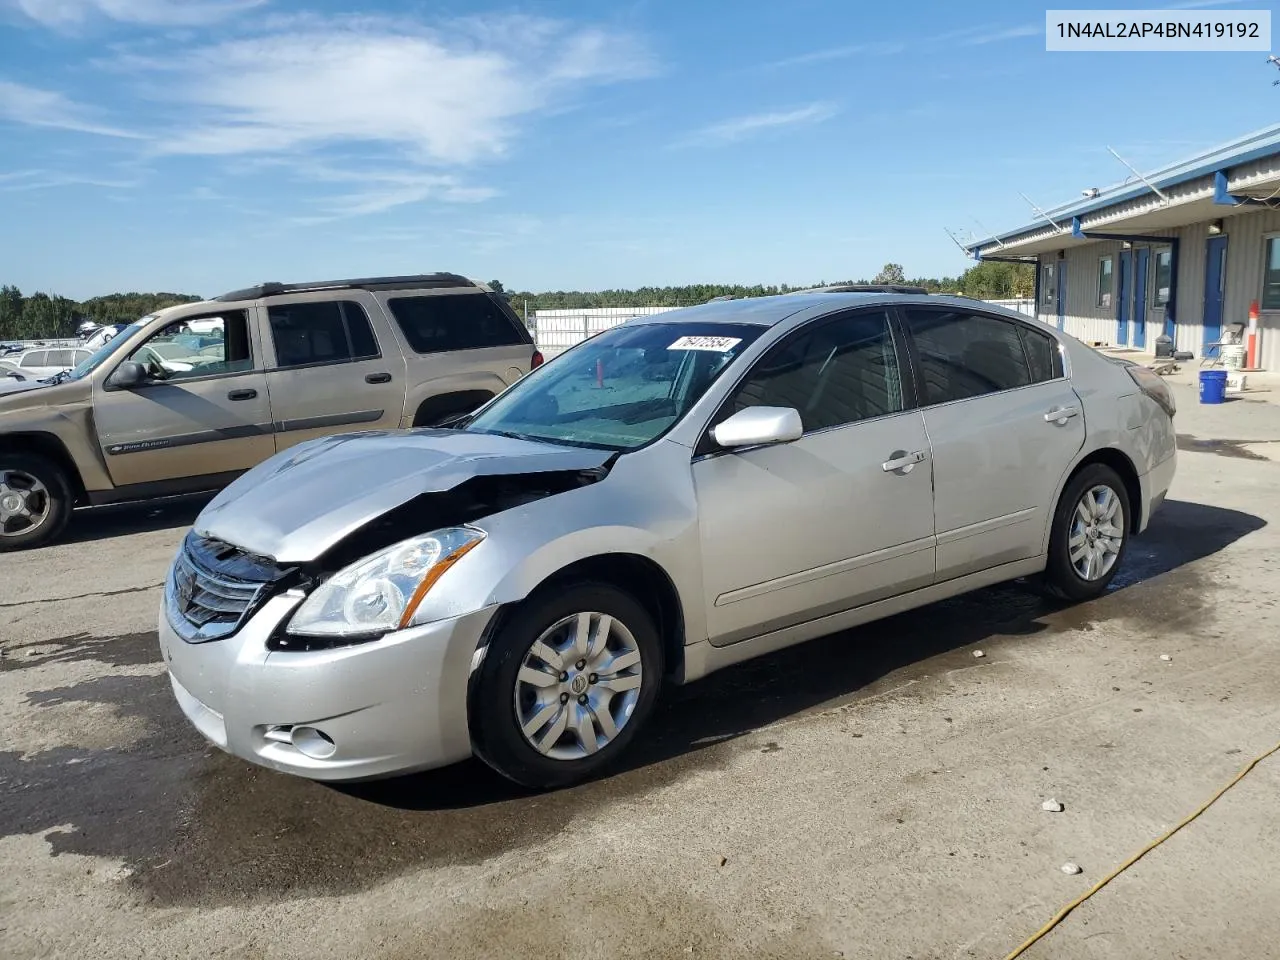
[165,532,287,643]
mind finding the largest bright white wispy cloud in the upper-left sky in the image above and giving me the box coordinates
[125,17,652,164]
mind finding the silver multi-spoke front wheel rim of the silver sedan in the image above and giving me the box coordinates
[515,612,644,760]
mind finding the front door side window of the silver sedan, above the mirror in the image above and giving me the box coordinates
[733,311,904,431]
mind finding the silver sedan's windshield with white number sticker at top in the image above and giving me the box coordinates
[463,323,762,451]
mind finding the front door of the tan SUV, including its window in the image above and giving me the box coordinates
[93,310,275,489]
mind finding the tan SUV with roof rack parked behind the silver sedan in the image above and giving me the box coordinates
[0,273,541,550]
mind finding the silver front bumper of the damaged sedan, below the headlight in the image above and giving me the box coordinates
[159,594,497,781]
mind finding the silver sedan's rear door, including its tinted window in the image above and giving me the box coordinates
[904,306,1084,581]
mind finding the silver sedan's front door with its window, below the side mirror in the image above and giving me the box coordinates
[692,308,933,645]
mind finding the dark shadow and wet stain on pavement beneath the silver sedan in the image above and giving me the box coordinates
[0,500,1263,904]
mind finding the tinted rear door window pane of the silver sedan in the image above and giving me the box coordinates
[906,310,1032,403]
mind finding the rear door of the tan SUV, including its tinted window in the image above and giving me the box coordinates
[262,291,406,451]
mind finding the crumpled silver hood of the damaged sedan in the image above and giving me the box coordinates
[195,430,613,563]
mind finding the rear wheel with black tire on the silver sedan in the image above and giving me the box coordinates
[1044,463,1132,602]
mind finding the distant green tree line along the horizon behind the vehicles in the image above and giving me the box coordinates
[0,261,1036,340]
